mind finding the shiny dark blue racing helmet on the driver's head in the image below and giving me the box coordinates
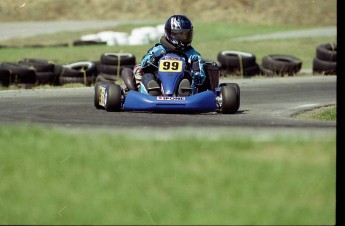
[164,15,193,50]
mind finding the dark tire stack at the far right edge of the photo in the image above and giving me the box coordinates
[313,43,337,75]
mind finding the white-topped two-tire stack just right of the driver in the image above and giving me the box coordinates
[217,50,260,77]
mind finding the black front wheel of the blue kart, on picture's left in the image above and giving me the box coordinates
[104,83,121,111]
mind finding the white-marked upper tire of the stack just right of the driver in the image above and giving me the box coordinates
[217,50,256,71]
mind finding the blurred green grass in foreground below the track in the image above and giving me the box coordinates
[0,125,336,225]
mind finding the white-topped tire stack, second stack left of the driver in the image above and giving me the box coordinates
[58,61,97,86]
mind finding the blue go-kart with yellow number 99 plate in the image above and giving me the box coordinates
[94,50,240,114]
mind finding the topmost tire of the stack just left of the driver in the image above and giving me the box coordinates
[100,53,136,66]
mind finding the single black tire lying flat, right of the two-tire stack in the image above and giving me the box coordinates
[262,54,302,76]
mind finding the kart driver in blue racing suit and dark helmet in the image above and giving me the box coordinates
[133,15,206,96]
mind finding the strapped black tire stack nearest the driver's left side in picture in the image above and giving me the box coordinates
[96,53,136,82]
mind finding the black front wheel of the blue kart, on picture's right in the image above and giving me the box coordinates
[220,86,239,114]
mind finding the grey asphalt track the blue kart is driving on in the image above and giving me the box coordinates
[0,76,337,131]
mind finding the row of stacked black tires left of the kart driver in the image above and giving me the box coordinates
[0,53,136,88]
